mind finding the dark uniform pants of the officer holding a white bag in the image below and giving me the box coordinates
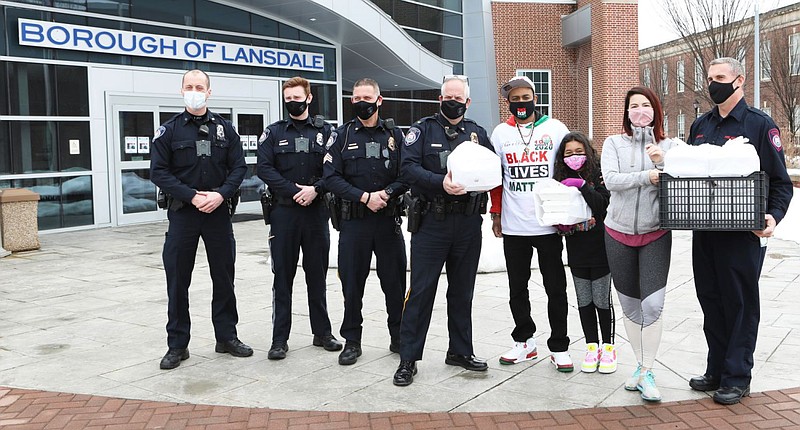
[400,213,481,361]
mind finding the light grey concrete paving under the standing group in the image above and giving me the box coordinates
[0,220,800,418]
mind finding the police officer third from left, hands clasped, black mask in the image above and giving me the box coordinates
[323,78,407,365]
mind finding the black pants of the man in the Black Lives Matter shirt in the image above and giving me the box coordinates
[503,233,568,352]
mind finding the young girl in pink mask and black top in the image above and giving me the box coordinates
[553,132,617,373]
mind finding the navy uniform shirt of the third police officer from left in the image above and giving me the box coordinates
[323,119,407,202]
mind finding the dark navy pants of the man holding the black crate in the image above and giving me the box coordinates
[692,231,766,387]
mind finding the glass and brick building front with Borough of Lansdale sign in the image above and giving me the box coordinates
[0,0,638,230]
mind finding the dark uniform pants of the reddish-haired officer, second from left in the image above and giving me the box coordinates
[269,200,331,342]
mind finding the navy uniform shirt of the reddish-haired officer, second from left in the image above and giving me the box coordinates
[258,115,333,198]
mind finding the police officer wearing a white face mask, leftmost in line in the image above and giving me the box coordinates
[150,70,253,369]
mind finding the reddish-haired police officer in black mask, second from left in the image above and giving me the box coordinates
[258,77,342,360]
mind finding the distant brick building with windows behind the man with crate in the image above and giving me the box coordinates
[639,3,800,161]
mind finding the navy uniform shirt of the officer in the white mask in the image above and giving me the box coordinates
[150,110,247,203]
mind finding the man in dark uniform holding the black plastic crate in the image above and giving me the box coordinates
[688,57,793,405]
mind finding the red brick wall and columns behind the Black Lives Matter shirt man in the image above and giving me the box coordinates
[492,0,639,148]
